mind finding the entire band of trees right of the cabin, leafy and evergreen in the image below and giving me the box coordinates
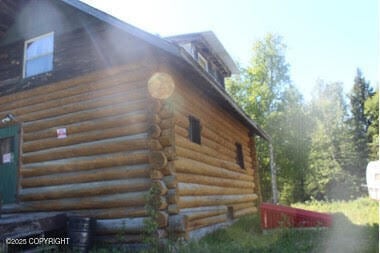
[226,34,379,203]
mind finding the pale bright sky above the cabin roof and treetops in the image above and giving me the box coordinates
[82,0,380,100]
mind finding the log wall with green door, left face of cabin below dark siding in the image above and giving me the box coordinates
[0,64,168,240]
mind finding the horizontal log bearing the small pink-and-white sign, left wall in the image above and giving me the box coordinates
[23,110,148,142]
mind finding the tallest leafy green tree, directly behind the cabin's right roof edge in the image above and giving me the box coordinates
[226,34,308,202]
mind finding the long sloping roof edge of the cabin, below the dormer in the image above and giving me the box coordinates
[0,0,270,141]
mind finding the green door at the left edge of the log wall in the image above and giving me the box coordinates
[0,125,20,204]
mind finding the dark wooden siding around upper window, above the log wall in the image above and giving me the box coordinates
[0,19,151,96]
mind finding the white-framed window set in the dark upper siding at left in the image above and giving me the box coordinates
[23,33,54,78]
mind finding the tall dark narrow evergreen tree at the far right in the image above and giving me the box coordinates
[348,69,374,178]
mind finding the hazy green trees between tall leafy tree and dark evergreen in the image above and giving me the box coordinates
[306,81,360,199]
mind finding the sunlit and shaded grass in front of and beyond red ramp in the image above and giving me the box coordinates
[90,198,379,253]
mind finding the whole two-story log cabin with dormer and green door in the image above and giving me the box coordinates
[0,0,270,243]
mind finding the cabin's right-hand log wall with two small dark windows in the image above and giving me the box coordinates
[165,69,258,238]
